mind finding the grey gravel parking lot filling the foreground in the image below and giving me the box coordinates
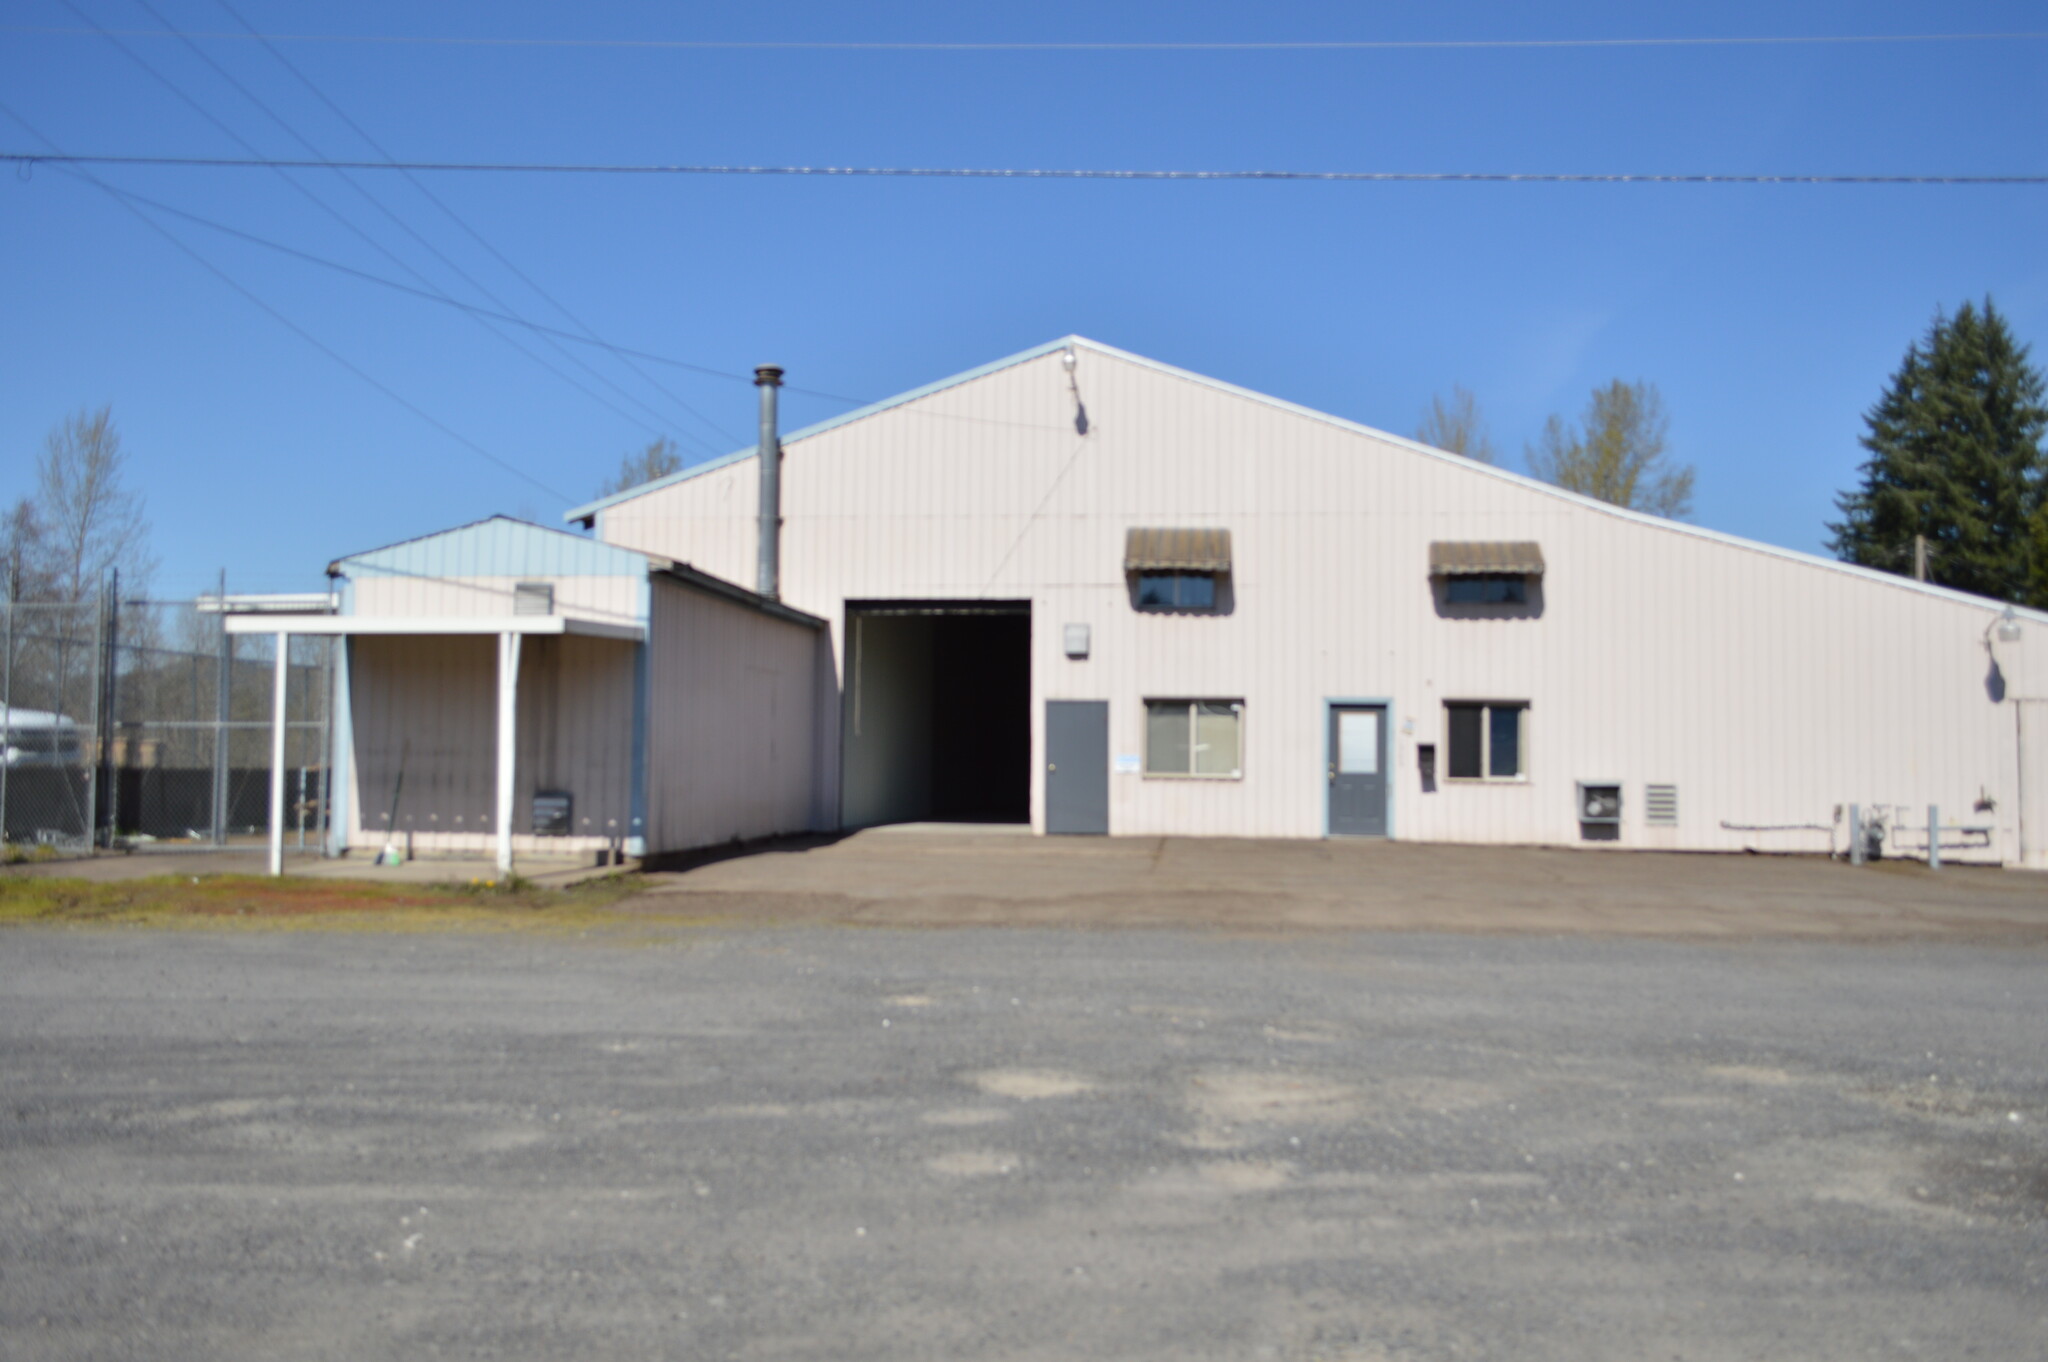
[0,909,2048,1362]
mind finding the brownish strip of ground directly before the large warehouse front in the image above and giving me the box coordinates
[627,827,2048,940]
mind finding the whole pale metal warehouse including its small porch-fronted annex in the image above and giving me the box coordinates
[250,338,2048,866]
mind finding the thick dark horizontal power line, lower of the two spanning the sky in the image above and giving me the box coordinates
[0,152,2048,184]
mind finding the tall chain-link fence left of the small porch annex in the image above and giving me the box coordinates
[0,585,336,854]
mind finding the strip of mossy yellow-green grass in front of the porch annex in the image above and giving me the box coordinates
[0,875,639,932]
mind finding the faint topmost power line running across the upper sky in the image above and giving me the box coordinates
[0,25,2048,53]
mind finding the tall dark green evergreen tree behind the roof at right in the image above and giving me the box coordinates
[1827,297,2048,602]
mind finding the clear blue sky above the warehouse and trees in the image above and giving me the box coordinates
[0,0,2048,594]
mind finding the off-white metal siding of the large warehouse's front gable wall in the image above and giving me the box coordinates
[598,346,2048,862]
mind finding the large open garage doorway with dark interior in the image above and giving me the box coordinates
[840,600,1030,827]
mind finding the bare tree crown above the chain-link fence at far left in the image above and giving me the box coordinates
[35,408,156,600]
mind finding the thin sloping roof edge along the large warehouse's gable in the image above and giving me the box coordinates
[563,334,2048,625]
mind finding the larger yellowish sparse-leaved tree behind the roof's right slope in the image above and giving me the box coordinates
[1528,379,1694,520]
